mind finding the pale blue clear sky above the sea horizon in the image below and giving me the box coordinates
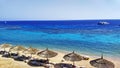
[0,0,120,20]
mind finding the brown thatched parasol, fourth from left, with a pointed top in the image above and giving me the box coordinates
[37,48,57,60]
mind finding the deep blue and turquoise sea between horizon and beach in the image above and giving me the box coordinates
[0,20,120,57]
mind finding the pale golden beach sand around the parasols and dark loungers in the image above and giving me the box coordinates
[0,47,120,68]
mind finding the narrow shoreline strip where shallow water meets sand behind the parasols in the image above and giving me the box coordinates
[5,44,120,60]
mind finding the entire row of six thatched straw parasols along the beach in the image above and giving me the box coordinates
[0,44,115,68]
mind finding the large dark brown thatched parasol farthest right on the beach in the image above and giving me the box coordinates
[90,55,115,68]
